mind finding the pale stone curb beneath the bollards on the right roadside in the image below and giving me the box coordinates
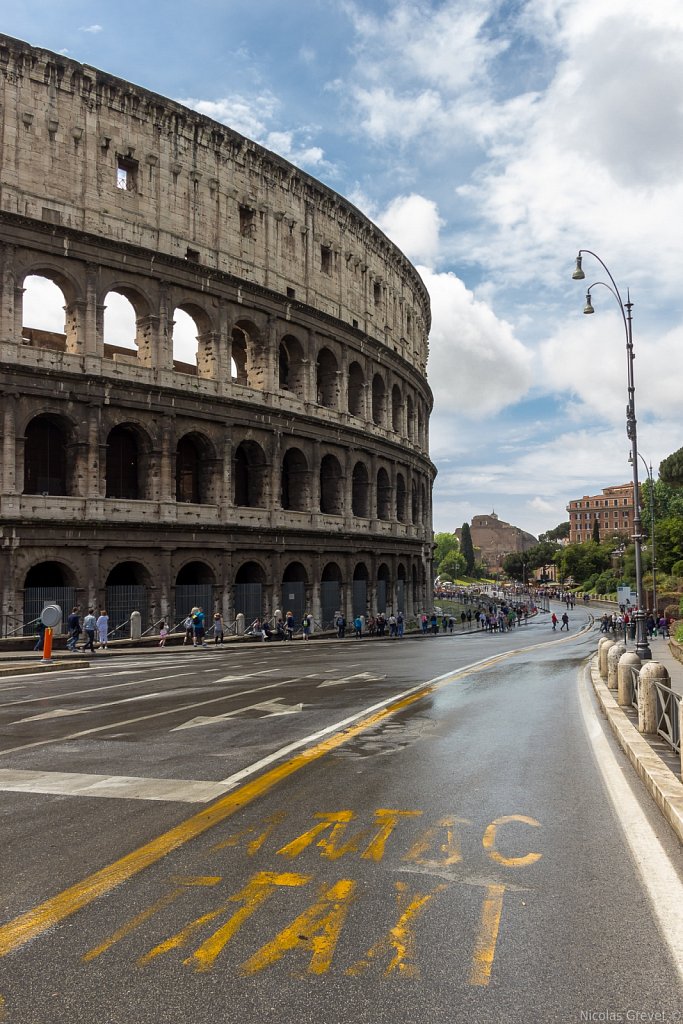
[590,655,683,843]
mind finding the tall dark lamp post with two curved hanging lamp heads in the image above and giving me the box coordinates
[571,249,652,660]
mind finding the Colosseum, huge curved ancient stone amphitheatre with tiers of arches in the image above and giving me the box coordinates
[0,36,435,635]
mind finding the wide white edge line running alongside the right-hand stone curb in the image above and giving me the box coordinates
[579,668,683,981]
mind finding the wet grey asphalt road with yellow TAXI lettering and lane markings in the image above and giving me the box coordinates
[0,609,683,1024]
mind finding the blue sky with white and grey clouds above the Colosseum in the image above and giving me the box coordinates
[6,0,683,536]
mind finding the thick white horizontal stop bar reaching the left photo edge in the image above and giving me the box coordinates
[0,768,225,804]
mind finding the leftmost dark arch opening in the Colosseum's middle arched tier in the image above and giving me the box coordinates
[24,413,74,495]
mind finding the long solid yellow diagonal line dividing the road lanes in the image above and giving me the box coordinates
[0,638,557,956]
